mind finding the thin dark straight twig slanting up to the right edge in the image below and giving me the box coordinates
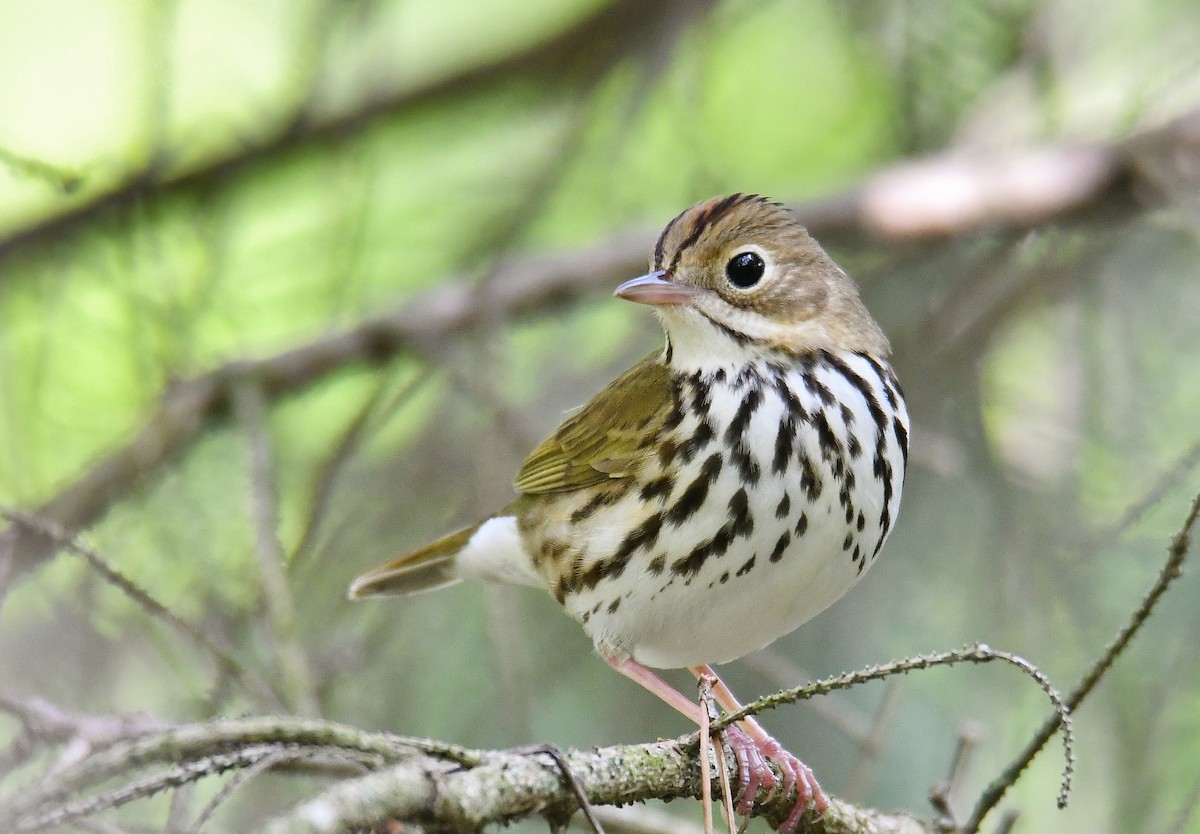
[962,493,1200,834]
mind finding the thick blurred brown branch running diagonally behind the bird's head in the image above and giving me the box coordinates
[0,112,1200,592]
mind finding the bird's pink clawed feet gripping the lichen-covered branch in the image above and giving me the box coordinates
[725,727,829,834]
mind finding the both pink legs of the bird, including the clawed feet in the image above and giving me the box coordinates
[602,655,828,834]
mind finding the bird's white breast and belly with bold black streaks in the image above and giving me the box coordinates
[565,354,908,667]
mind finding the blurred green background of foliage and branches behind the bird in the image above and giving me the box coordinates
[0,0,1200,834]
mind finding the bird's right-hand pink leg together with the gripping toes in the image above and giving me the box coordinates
[690,666,829,834]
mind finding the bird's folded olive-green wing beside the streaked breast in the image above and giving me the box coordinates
[516,353,672,493]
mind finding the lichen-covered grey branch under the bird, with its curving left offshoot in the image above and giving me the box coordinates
[0,716,928,834]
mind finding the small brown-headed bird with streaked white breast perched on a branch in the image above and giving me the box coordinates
[349,193,910,834]
